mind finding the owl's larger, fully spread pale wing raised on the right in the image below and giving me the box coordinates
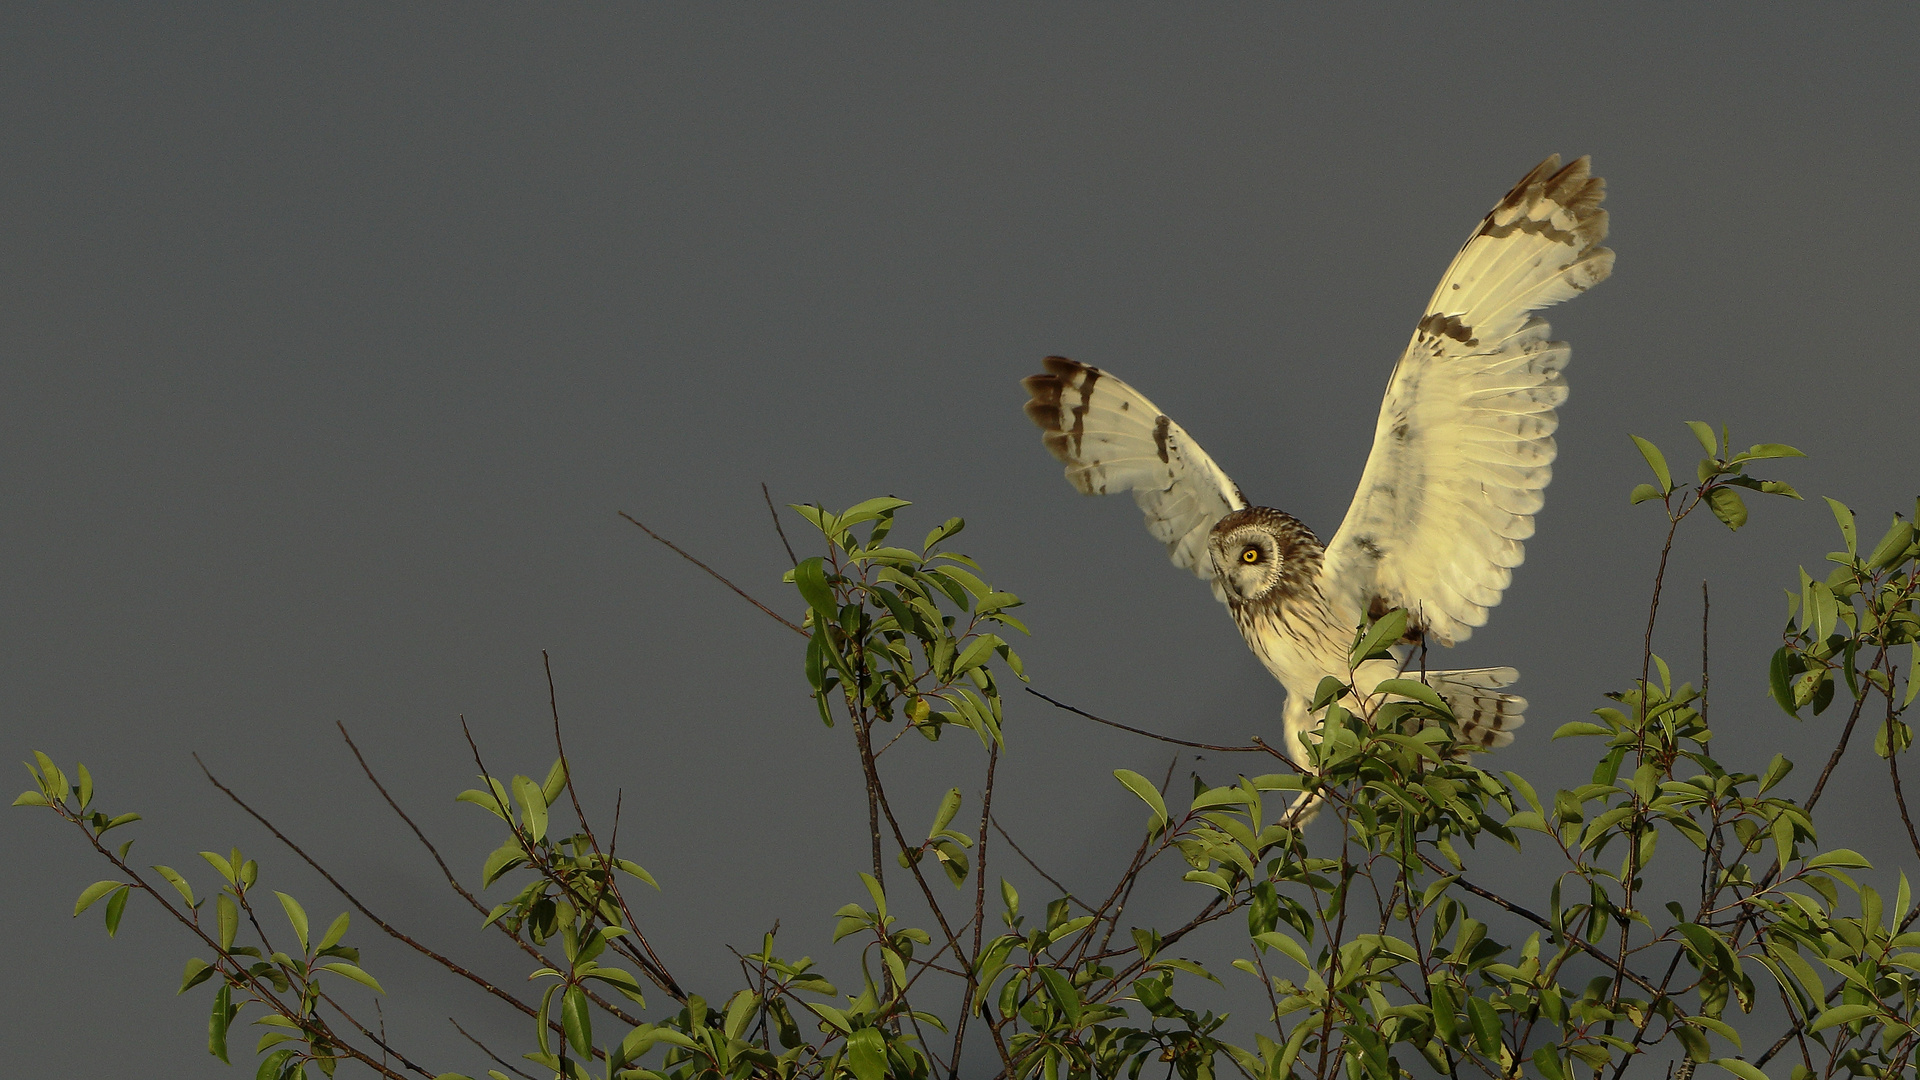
[1321,156,1613,644]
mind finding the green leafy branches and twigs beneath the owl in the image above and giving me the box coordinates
[17,423,1920,1080]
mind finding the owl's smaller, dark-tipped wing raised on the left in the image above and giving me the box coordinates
[1023,356,1246,596]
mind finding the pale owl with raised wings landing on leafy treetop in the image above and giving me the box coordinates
[1025,156,1613,791]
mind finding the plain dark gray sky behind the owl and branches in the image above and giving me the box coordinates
[0,6,1920,1076]
